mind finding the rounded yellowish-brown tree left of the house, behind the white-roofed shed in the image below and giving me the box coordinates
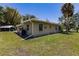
[4,7,21,25]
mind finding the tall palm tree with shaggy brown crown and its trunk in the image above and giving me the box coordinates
[61,3,74,33]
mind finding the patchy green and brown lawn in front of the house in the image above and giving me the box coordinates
[0,32,79,56]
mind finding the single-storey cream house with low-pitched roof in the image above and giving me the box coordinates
[16,18,59,36]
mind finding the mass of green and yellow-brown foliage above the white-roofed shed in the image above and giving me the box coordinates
[0,7,21,25]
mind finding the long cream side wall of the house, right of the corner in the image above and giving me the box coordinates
[32,22,58,36]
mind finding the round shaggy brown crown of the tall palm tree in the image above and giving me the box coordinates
[61,3,74,17]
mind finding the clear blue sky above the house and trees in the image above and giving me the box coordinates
[0,3,79,23]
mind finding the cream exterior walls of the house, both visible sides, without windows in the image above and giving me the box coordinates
[19,22,59,36]
